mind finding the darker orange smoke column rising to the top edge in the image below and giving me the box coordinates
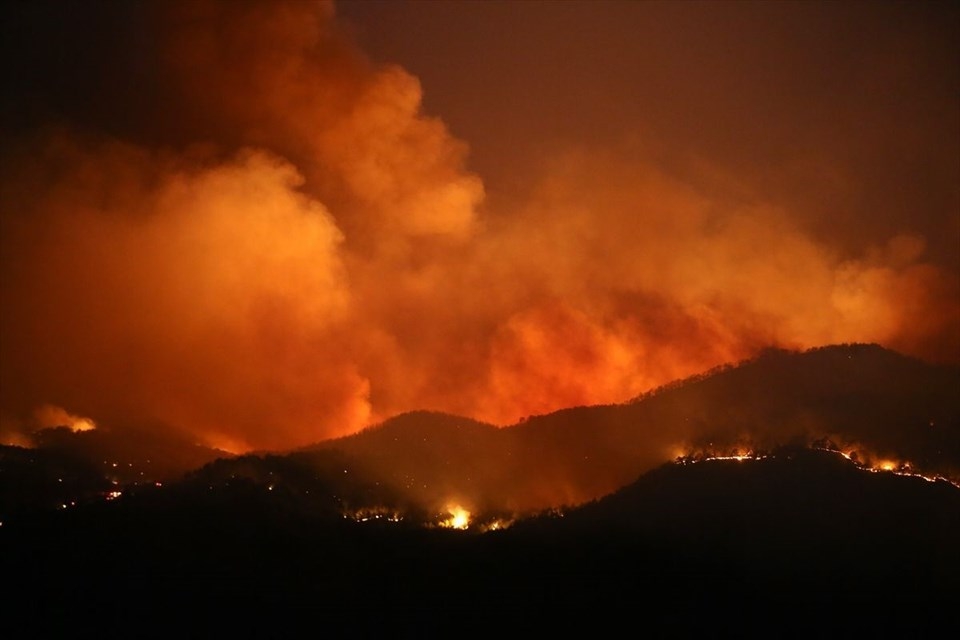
[165,2,483,245]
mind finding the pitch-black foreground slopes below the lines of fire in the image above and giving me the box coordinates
[0,449,960,638]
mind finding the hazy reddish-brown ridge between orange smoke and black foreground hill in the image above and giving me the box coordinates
[306,345,960,511]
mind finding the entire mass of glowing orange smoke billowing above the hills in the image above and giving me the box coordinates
[0,1,960,450]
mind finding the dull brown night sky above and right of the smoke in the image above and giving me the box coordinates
[337,0,960,264]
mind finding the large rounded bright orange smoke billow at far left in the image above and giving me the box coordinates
[3,140,368,448]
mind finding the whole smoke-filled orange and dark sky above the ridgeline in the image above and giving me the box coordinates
[0,0,960,451]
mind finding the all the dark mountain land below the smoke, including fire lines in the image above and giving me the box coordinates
[0,345,960,638]
